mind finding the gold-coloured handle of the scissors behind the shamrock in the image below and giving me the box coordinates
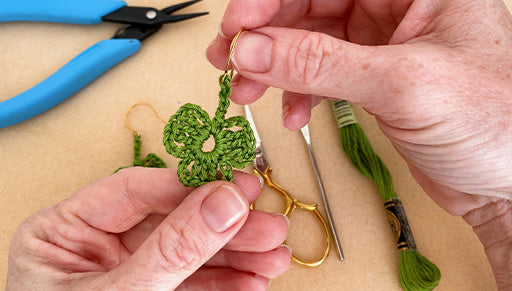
[251,167,330,267]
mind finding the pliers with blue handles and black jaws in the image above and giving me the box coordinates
[0,0,207,128]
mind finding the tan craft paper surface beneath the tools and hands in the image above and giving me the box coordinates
[0,0,511,291]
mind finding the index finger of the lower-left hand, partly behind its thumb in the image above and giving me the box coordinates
[57,167,260,233]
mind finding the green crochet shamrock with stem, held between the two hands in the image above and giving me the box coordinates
[164,73,255,187]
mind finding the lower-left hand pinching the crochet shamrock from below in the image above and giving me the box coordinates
[6,168,290,290]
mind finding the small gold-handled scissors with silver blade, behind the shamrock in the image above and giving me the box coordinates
[244,105,330,267]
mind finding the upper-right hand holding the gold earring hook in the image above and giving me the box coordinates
[207,0,512,215]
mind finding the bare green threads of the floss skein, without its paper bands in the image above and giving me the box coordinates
[339,101,441,291]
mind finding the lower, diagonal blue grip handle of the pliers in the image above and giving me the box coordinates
[0,38,141,128]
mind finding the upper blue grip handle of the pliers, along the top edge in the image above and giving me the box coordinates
[0,0,126,24]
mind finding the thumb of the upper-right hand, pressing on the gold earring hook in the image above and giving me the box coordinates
[232,27,416,108]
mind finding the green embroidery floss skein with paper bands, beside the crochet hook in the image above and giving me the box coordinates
[332,100,441,291]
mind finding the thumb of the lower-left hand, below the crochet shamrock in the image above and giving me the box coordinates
[111,181,249,290]
